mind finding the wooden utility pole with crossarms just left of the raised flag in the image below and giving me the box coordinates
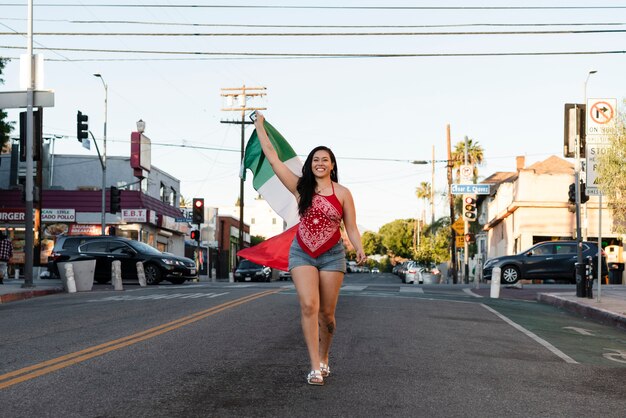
[221,84,266,258]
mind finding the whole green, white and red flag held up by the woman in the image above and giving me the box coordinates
[237,120,302,271]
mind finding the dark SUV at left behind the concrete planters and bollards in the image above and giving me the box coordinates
[48,235,197,284]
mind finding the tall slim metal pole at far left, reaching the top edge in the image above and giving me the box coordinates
[22,0,34,288]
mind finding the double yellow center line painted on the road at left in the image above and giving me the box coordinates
[0,289,281,389]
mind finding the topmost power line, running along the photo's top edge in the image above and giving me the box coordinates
[0,3,626,11]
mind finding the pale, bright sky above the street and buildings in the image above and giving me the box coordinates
[0,0,626,231]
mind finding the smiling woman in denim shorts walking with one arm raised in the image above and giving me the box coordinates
[254,112,366,385]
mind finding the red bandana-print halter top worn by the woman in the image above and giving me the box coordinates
[296,183,343,258]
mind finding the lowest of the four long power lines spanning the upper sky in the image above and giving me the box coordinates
[0,45,626,61]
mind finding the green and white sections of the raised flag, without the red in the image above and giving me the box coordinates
[240,117,302,228]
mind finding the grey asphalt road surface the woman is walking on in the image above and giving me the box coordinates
[0,274,626,417]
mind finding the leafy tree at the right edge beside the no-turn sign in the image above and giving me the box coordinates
[597,100,626,234]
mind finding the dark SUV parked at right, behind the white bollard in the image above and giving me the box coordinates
[483,241,608,284]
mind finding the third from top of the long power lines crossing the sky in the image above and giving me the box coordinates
[0,29,626,37]
